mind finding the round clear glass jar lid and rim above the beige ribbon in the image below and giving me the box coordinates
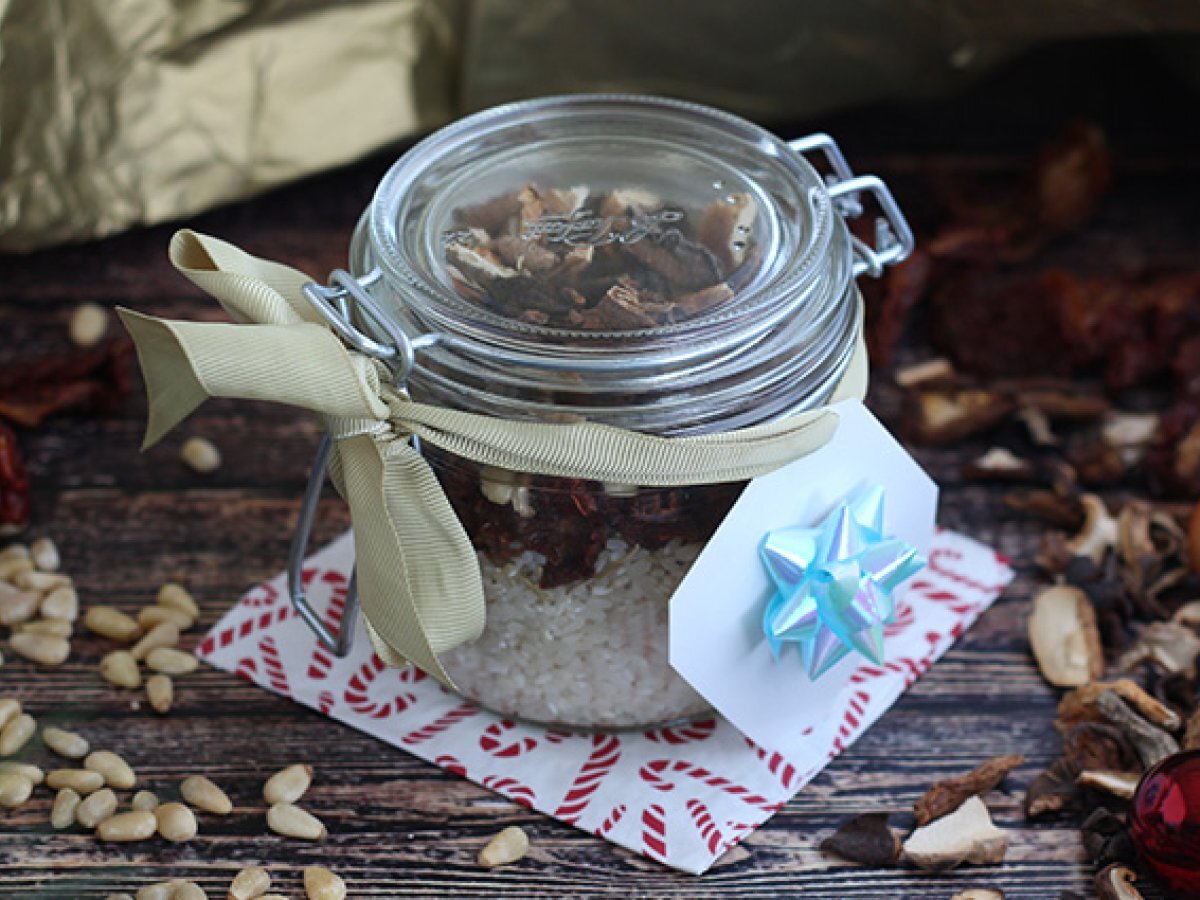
[352,95,890,433]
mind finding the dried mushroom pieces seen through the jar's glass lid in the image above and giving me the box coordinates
[442,182,761,332]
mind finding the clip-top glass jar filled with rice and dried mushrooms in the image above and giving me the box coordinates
[292,96,912,728]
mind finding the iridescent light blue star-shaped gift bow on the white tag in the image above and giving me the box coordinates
[761,485,925,678]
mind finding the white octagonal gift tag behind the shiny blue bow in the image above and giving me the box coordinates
[671,400,937,755]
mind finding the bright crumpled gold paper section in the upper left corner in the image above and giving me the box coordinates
[0,0,463,250]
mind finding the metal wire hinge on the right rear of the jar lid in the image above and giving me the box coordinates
[788,134,916,278]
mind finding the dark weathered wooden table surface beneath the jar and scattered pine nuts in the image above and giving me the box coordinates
[0,95,1200,900]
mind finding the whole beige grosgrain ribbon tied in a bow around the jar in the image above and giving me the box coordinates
[120,230,866,686]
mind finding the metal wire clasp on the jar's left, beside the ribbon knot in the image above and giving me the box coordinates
[288,269,415,656]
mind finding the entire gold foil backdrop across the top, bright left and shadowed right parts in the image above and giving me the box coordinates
[0,0,1200,250]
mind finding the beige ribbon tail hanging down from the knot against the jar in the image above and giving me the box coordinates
[337,434,485,686]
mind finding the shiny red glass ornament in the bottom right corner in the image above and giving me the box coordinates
[1129,750,1200,898]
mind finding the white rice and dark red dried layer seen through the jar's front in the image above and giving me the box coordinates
[427,450,743,727]
